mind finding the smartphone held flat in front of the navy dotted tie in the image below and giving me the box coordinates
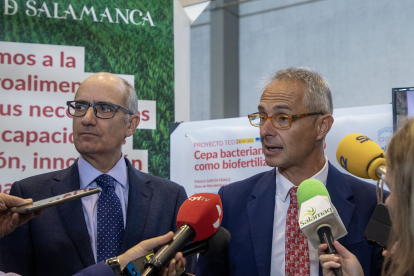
[10,188,101,214]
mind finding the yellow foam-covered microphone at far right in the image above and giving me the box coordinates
[336,133,387,180]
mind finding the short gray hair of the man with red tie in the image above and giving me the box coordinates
[265,67,333,114]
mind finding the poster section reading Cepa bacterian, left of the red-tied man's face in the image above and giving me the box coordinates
[171,117,271,196]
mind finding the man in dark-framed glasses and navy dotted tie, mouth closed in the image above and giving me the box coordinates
[0,73,187,276]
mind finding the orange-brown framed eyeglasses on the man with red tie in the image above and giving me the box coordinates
[247,112,324,129]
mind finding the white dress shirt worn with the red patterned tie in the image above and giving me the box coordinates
[270,156,328,276]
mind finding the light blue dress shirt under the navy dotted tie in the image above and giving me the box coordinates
[78,155,129,262]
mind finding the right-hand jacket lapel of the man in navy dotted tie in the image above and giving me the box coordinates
[121,159,152,252]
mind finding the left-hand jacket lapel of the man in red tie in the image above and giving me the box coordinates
[247,169,276,275]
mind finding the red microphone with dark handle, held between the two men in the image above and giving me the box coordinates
[142,193,223,276]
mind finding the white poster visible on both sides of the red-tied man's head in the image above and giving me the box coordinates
[171,105,392,196]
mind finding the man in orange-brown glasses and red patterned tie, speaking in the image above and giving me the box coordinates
[196,68,382,276]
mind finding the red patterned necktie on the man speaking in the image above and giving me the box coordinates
[285,187,310,276]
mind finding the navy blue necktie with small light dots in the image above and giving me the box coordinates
[95,174,124,262]
